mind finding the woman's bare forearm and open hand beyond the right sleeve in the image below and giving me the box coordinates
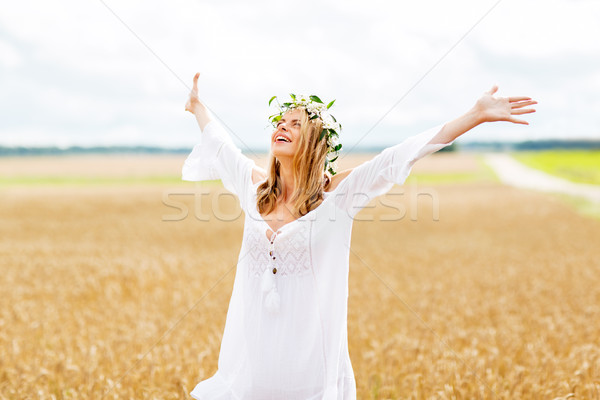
[430,85,537,144]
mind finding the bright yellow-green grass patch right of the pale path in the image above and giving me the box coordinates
[513,150,600,185]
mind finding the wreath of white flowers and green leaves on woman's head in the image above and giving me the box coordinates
[269,93,342,175]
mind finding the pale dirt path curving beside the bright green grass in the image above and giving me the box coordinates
[485,153,600,203]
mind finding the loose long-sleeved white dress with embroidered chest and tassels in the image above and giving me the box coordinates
[182,121,450,400]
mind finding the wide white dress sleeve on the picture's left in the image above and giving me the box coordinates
[181,120,255,205]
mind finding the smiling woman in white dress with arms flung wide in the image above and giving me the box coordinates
[183,73,536,400]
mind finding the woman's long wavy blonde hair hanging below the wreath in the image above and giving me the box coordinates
[256,108,331,217]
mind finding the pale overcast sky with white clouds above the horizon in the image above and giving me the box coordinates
[0,0,600,150]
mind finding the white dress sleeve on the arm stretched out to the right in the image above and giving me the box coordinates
[334,124,454,217]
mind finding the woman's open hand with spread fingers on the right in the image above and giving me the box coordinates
[474,85,537,125]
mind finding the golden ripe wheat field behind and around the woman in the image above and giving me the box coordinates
[0,155,600,399]
